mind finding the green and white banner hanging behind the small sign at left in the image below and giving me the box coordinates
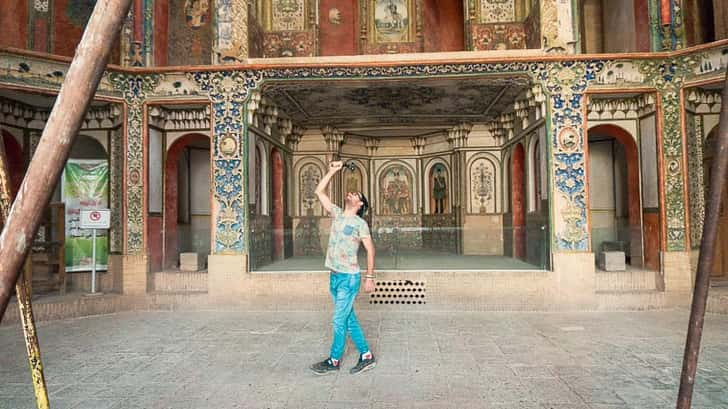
[61,159,109,271]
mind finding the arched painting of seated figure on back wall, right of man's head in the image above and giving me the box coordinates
[378,165,416,216]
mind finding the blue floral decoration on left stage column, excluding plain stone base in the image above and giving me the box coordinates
[190,71,262,254]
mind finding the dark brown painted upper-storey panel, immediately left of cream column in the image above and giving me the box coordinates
[167,0,212,65]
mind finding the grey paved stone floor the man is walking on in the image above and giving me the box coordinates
[0,310,728,409]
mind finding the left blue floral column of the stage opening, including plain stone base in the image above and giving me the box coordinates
[190,71,262,296]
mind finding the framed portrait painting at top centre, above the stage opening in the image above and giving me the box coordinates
[370,0,414,43]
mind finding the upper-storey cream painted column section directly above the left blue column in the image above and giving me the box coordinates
[213,0,249,64]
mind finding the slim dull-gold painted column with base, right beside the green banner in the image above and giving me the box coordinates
[109,73,159,294]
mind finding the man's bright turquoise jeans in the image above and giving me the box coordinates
[329,272,369,359]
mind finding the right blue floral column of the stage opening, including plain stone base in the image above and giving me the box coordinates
[535,61,604,307]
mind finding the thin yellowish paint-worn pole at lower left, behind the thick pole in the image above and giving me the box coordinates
[0,134,49,409]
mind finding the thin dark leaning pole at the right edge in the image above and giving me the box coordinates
[677,71,728,409]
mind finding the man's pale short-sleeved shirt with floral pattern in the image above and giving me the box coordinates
[326,205,371,274]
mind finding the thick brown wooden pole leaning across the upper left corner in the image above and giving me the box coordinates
[0,0,131,320]
